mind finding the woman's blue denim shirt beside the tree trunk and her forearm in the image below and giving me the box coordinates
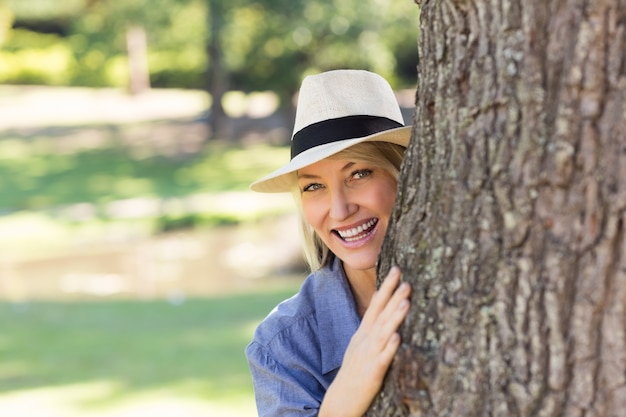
[246,258,361,417]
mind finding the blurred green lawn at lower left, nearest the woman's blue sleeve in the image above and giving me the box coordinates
[0,283,295,417]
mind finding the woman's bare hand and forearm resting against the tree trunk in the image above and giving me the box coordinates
[319,267,411,417]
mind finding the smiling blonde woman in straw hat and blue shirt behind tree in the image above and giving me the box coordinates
[246,70,410,417]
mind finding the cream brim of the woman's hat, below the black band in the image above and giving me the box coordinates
[250,126,411,193]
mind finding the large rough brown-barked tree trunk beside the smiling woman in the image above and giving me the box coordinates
[368,0,626,417]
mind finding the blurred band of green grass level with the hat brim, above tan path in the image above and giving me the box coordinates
[0,137,288,212]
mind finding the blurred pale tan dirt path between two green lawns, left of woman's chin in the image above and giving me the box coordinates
[0,216,304,303]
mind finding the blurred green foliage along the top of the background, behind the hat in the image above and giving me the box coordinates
[0,0,419,90]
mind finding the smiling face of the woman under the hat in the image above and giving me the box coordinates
[298,159,397,270]
